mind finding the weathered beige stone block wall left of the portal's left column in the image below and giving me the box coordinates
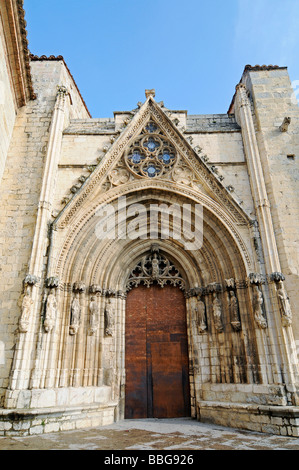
[0,61,88,404]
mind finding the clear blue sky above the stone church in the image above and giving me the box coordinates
[24,0,299,118]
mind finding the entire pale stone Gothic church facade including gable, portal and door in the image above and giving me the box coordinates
[0,0,299,436]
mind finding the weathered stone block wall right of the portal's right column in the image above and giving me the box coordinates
[243,68,299,345]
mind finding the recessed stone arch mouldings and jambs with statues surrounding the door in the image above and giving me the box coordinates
[15,176,282,416]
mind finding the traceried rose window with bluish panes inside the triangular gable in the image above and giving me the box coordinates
[125,121,177,178]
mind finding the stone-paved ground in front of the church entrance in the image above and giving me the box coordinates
[0,418,299,455]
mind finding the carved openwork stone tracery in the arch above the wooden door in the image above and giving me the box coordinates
[127,247,186,291]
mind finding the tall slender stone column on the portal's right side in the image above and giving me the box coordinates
[235,83,299,394]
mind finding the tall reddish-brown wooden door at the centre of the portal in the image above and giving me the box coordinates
[125,286,190,419]
